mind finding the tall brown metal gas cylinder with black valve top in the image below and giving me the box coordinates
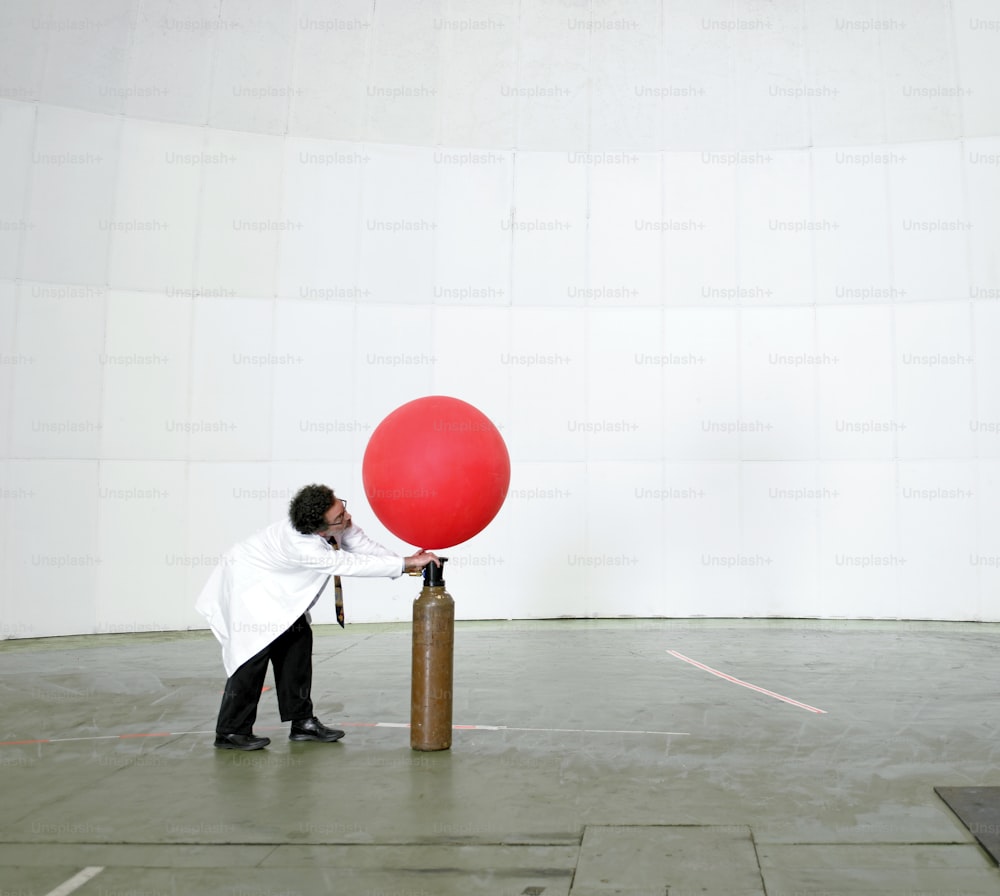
[410,557,455,751]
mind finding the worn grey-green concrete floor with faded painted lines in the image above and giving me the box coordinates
[0,620,1000,896]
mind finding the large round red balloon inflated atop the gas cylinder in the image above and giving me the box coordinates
[361,395,510,551]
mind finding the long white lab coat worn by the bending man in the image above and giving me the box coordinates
[195,520,405,676]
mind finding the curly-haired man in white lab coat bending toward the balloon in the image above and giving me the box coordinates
[195,485,438,750]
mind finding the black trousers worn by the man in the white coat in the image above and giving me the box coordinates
[215,616,313,734]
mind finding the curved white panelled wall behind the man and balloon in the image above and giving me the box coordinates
[0,0,1000,637]
